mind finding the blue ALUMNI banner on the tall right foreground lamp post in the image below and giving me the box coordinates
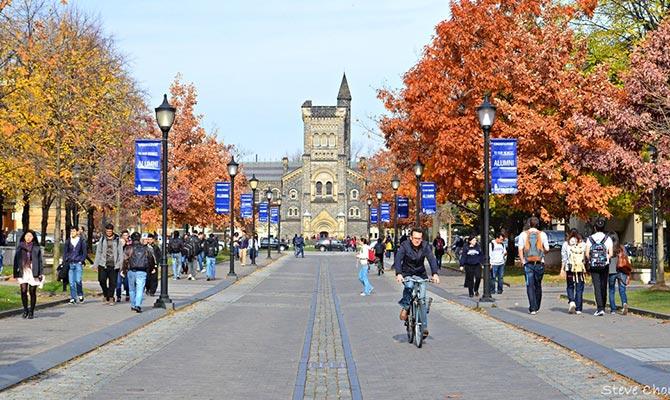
[491,139,518,194]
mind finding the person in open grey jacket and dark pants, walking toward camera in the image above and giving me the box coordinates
[93,224,123,305]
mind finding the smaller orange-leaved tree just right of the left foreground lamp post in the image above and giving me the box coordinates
[142,76,247,227]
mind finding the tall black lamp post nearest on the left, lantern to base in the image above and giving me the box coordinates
[154,94,177,308]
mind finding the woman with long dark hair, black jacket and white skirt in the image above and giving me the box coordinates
[13,230,44,319]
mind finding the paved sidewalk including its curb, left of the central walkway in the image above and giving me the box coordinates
[0,253,286,390]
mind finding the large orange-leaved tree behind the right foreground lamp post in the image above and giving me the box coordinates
[379,0,618,219]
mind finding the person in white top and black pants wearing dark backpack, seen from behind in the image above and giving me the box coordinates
[586,218,614,317]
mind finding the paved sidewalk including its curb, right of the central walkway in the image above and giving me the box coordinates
[386,256,670,387]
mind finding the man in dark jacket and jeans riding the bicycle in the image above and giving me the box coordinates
[393,228,440,337]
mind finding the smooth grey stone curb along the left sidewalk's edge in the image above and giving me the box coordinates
[0,256,282,393]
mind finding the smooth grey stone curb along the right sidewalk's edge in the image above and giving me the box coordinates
[429,285,668,387]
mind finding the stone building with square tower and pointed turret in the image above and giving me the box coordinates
[243,75,368,240]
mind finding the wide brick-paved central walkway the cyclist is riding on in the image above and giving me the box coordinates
[1,254,660,399]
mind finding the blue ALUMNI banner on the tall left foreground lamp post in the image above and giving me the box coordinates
[135,139,161,196]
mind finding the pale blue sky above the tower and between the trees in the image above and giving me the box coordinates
[69,0,449,161]
